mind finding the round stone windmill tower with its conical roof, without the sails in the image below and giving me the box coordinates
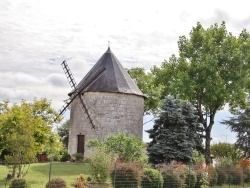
[61,48,145,155]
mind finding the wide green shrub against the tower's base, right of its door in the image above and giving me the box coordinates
[87,133,144,162]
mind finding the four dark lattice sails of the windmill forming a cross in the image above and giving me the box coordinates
[58,61,106,129]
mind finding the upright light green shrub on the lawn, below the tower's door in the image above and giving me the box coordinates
[88,148,114,183]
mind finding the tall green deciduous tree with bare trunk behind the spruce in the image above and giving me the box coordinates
[152,22,250,163]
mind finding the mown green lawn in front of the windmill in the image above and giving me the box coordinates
[0,162,92,188]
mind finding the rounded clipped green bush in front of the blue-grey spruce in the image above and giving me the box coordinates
[141,168,163,188]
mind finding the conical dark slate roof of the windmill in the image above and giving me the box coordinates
[77,47,145,97]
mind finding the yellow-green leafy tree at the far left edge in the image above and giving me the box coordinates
[0,99,60,177]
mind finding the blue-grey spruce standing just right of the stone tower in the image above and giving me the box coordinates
[147,96,202,164]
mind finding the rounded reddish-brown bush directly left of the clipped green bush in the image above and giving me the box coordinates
[110,163,142,188]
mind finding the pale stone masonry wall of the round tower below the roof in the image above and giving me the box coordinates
[68,92,144,155]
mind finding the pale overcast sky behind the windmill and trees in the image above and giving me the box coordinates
[0,0,250,142]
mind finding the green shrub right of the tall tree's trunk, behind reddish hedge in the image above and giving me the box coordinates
[211,142,241,166]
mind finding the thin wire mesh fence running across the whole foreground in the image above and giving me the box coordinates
[0,162,250,188]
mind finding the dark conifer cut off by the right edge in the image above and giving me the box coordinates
[221,108,250,159]
